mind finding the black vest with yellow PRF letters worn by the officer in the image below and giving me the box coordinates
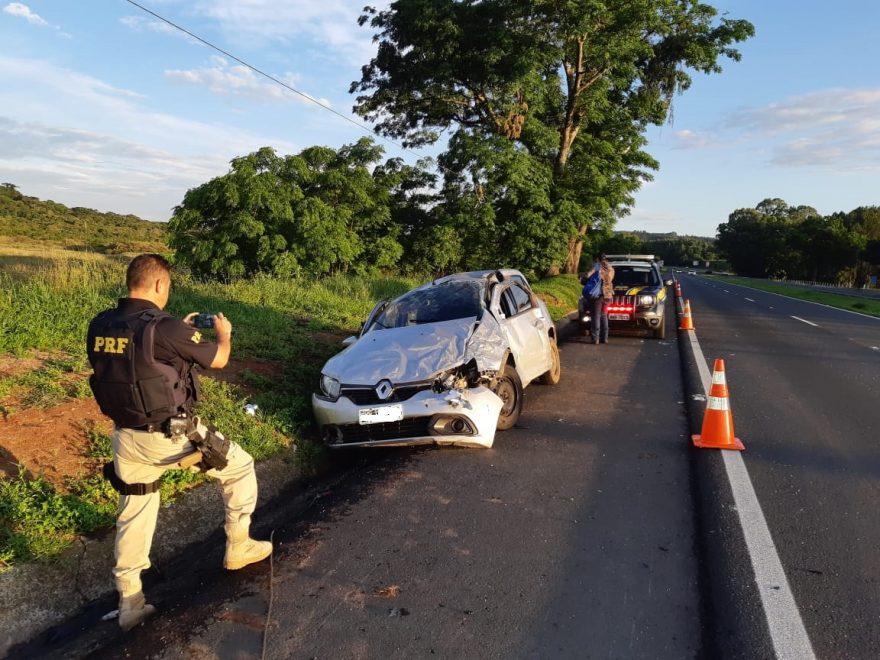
[87,309,197,428]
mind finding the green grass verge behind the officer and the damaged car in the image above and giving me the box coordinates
[0,250,580,570]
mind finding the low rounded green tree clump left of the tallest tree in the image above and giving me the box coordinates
[169,138,420,279]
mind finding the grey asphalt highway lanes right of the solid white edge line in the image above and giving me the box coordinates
[681,276,880,658]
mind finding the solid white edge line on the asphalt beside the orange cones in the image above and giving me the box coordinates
[688,332,816,660]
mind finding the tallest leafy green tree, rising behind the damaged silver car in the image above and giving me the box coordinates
[352,0,753,272]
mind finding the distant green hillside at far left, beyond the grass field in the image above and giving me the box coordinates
[0,183,168,253]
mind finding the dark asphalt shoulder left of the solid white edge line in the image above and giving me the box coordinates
[43,315,704,658]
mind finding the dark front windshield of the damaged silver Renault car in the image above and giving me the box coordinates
[370,280,483,330]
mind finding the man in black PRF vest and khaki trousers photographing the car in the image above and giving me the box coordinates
[87,254,272,630]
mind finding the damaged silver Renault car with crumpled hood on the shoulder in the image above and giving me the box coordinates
[312,269,561,447]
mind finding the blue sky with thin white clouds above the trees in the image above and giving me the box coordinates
[0,0,880,236]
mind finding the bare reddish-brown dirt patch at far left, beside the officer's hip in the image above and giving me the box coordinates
[0,399,113,489]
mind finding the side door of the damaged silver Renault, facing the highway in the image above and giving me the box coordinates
[498,282,550,384]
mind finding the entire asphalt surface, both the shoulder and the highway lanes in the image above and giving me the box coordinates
[18,276,880,659]
